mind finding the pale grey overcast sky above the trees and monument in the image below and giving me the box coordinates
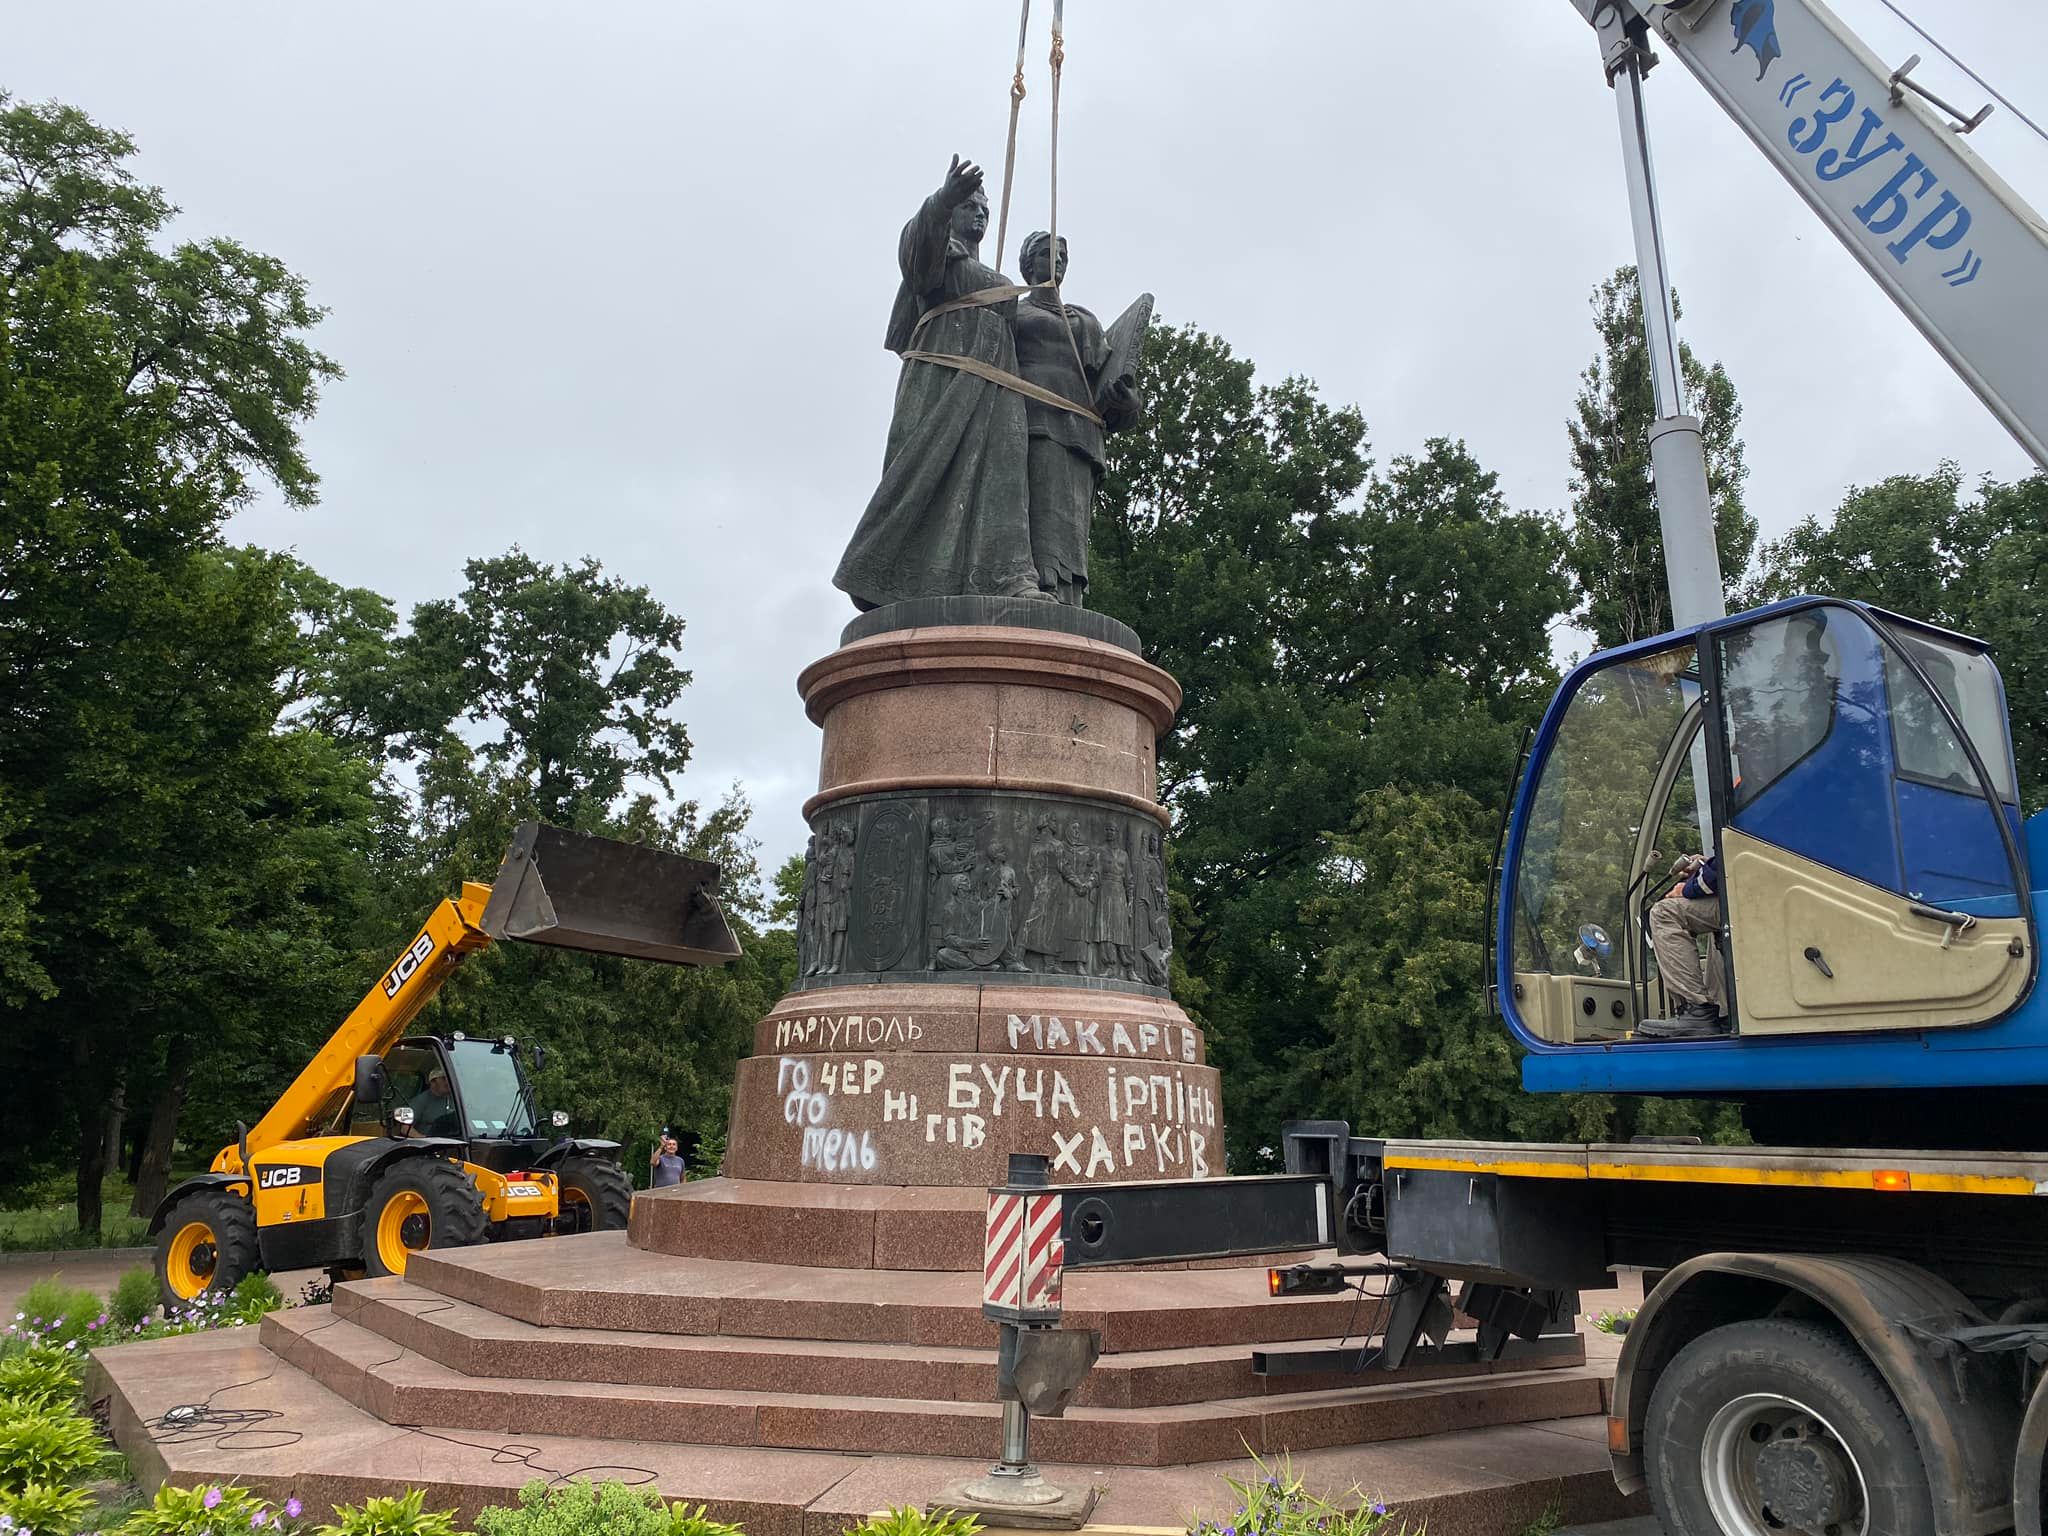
[16,0,2048,868]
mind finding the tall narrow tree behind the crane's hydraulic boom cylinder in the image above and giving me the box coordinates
[1567,266,1757,647]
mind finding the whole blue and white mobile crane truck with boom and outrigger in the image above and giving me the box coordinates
[985,0,2048,1536]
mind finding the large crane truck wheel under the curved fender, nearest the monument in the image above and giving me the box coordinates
[1642,1319,1935,1536]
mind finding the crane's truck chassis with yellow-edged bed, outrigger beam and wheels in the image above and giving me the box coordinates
[1019,1120,2048,1536]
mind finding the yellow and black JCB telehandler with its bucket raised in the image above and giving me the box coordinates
[150,821,739,1307]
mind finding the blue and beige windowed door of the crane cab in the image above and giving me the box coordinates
[1708,602,2032,1036]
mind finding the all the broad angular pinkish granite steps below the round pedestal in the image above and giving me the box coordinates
[94,1233,1628,1536]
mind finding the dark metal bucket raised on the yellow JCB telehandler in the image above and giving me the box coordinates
[481,821,739,965]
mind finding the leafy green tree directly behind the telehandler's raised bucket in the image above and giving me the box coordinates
[387,549,797,1161]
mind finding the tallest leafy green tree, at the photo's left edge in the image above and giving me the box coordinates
[0,96,348,1231]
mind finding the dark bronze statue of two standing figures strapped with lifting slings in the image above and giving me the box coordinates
[831,156,1151,610]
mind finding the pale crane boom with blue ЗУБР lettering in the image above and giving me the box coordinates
[1597,0,2048,469]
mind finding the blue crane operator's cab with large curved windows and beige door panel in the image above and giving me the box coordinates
[1491,598,2048,1135]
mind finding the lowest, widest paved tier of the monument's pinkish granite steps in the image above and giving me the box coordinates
[88,1329,1642,1536]
